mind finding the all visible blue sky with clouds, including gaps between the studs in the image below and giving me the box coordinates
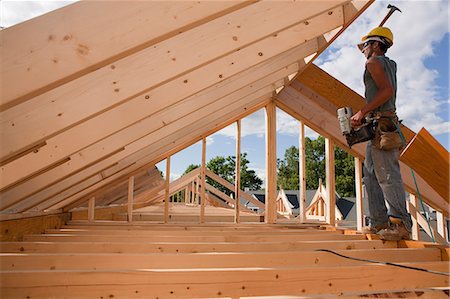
[0,0,450,184]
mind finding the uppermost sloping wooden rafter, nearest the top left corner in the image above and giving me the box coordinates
[0,1,250,110]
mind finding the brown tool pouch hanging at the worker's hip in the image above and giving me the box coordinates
[373,114,403,151]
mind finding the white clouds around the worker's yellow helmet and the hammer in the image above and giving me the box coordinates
[316,0,450,135]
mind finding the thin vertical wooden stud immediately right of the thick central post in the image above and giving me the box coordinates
[298,121,307,223]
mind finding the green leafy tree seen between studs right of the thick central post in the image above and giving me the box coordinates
[277,136,355,196]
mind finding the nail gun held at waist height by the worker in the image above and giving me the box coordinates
[337,107,378,148]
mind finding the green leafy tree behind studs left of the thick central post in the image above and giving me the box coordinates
[183,153,263,195]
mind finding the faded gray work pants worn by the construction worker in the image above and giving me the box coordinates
[363,141,412,231]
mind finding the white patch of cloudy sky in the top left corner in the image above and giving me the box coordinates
[0,0,75,28]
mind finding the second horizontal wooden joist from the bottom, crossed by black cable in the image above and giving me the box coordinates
[1,248,441,271]
